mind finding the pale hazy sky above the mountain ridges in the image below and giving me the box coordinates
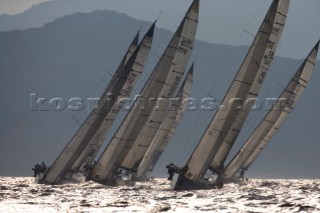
[0,0,320,59]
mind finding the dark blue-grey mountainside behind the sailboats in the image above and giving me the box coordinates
[0,11,320,177]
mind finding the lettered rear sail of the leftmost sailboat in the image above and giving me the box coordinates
[71,22,155,173]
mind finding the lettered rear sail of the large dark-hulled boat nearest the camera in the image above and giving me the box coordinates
[210,0,290,171]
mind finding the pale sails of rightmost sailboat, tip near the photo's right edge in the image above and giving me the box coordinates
[221,41,319,179]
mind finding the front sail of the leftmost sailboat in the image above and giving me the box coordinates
[38,24,154,184]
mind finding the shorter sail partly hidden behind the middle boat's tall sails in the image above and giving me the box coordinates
[136,64,193,178]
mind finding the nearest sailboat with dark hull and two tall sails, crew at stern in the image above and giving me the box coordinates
[172,0,290,190]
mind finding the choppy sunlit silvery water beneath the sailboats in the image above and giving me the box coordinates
[0,177,320,212]
